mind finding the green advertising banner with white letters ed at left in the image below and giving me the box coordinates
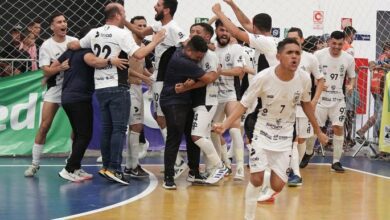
[0,71,71,155]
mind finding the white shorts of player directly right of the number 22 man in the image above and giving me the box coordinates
[129,85,144,125]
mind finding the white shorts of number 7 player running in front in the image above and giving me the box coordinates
[249,143,292,183]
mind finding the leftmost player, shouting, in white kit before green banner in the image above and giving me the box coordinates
[24,13,76,177]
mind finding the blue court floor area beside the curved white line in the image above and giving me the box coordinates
[0,156,390,220]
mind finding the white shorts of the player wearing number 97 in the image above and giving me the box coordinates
[316,101,346,127]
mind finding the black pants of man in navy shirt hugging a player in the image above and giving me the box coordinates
[161,105,200,177]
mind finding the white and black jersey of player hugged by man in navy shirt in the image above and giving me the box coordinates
[192,50,219,107]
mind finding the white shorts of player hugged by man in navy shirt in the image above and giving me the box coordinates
[191,105,217,138]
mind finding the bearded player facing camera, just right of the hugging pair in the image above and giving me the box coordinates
[211,20,245,180]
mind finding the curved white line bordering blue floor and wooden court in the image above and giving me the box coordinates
[55,169,158,220]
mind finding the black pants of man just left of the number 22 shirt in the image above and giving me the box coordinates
[62,102,93,172]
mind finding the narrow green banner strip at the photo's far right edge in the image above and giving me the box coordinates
[379,73,390,153]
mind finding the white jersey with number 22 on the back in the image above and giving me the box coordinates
[80,25,139,89]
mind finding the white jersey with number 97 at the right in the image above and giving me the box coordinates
[314,48,356,108]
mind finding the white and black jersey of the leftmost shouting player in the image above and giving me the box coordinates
[39,35,77,87]
